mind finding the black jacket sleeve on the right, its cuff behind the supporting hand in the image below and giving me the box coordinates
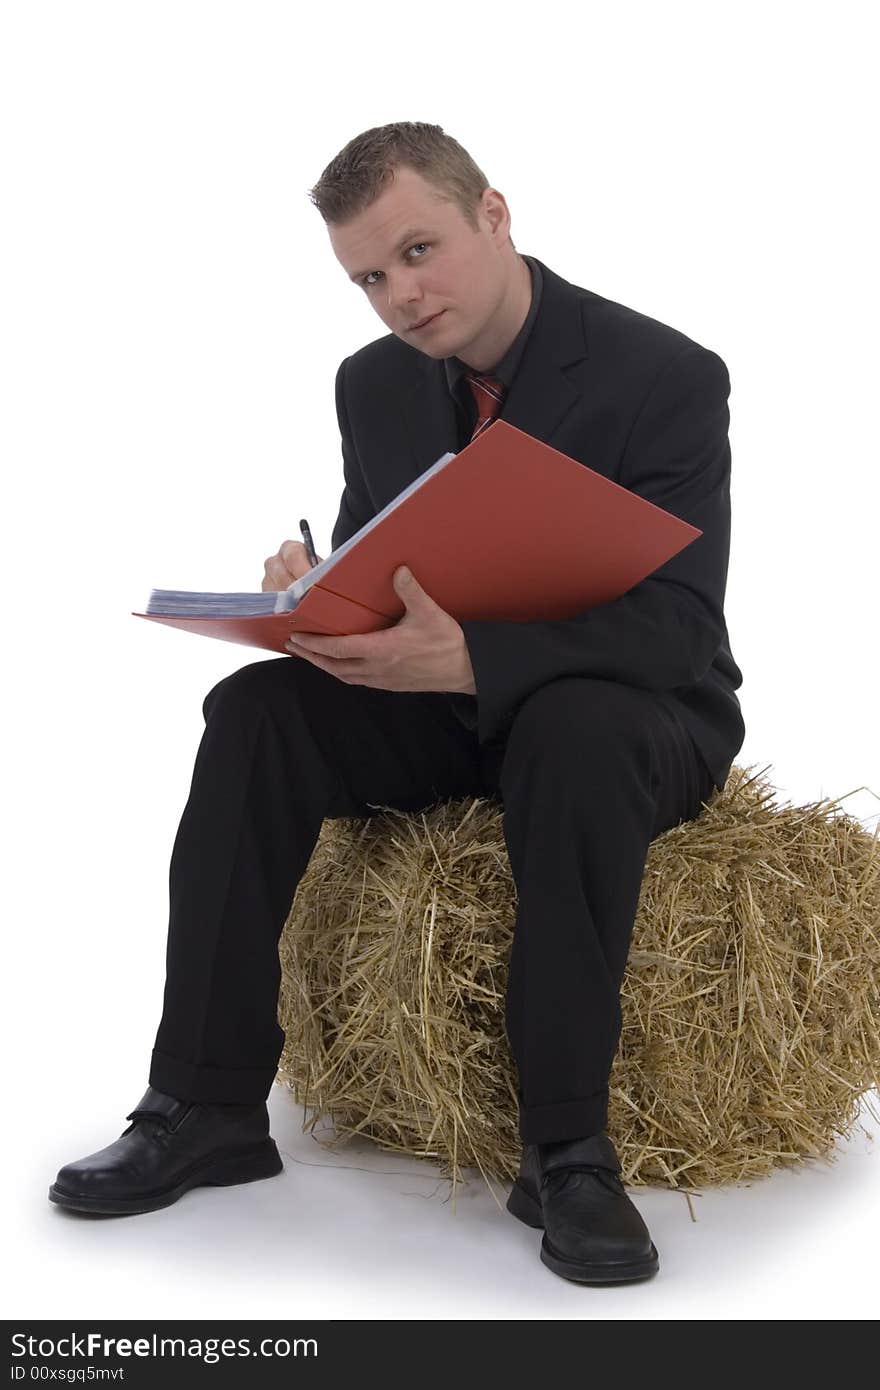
[462,345,730,742]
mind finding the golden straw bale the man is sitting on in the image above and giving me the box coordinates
[278,765,880,1188]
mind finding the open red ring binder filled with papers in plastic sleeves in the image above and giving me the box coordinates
[135,420,702,652]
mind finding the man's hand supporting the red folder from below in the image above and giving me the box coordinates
[283,564,477,695]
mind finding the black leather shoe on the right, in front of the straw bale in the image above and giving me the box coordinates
[507,1134,660,1284]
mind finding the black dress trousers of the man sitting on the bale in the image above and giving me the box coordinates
[150,656,713,1143]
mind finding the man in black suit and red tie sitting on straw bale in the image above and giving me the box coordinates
[50,122,744,1283]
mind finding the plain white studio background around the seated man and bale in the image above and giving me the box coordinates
[0,0,880,1319]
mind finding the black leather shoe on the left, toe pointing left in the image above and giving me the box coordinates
[49,1086,284,1216]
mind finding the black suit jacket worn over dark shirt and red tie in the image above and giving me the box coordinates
[332,261,745,787]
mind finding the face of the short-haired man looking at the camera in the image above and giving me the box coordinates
[328,165,517,360]
